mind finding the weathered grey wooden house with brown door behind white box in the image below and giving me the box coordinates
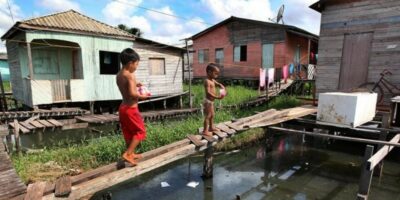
[310,0,400,93]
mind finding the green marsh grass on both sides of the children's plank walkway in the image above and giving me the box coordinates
[12,86,299,182]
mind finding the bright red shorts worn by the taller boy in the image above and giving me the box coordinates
[118,104,146,144]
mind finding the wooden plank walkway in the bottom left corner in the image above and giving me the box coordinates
[0,137,26,200]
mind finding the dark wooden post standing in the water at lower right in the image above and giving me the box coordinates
[357,145,374,200]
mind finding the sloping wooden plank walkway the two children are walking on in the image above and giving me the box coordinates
[39,106,316,199]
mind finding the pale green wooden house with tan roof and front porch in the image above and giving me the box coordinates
[2,10,183,107]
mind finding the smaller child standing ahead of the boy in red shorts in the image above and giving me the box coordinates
[203,63,224,136]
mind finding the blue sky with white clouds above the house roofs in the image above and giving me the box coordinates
[0,0,321,52]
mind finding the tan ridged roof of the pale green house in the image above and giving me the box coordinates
[2,10,135,40]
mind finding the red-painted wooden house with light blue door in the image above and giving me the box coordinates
[191,16,318,80]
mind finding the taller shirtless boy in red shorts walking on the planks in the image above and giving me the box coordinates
[117,48,147,166]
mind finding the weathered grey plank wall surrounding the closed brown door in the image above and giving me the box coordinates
[316,0,400,93]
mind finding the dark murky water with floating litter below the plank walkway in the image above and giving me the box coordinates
[92,135,400,200]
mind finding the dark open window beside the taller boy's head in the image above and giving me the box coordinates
[100,51,120,74]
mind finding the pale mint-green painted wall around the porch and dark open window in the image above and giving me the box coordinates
[26,32,133,101]
